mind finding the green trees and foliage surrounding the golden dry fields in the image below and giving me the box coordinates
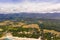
[0,19,60,40]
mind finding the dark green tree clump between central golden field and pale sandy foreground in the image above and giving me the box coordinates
[9,27,39,38]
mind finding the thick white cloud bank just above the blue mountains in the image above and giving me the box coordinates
[0,2,60,13]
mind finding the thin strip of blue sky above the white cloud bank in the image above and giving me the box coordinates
[0,0,60,3]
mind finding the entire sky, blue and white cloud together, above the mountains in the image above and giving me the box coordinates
[0,0,60,13]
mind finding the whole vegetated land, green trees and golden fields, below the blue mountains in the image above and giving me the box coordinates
[0,19,60,40]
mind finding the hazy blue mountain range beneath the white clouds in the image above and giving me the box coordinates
[0,13,60,20]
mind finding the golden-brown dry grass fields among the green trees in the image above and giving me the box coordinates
[0,21,60,35]
